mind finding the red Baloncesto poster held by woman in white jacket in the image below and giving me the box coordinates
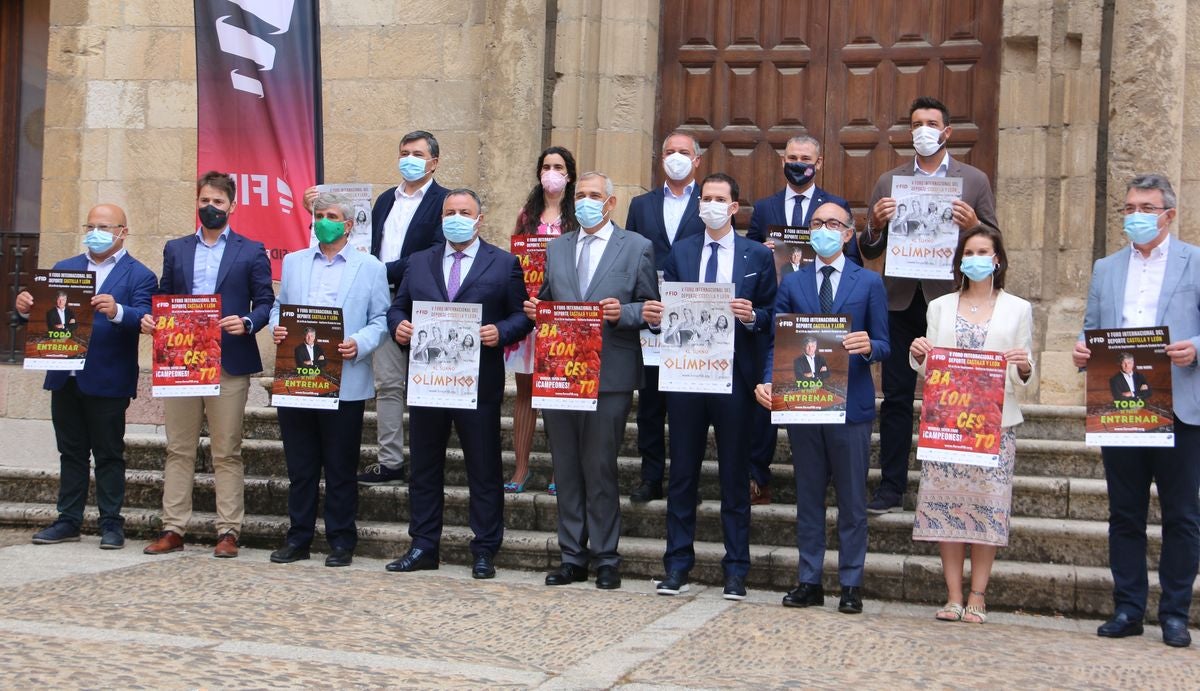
[917,348,1008,468]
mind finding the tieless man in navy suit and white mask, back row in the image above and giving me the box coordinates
[625,132,704,504]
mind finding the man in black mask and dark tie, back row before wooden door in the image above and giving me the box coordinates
[746,134,863,504]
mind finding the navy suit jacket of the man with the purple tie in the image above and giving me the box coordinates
[388,238,533,403]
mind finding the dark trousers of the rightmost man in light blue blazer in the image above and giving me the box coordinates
[1100,417,1200,620]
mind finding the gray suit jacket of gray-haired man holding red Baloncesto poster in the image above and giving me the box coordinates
[538,223,659,393]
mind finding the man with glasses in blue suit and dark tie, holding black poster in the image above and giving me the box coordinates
[756,203,890,614]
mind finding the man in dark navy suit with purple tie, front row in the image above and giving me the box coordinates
[388,188,533,578]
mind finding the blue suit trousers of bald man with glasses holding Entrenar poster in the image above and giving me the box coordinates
[787,422,871,585]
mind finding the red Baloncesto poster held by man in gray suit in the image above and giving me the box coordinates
[533,301,604,410]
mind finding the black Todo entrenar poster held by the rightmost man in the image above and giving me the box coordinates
[1084,326,1175,446]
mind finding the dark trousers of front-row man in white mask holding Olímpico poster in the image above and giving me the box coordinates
[662,388,755,578]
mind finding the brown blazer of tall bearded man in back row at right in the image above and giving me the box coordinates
[858,156,1000,311]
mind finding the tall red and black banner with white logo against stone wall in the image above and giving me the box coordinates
[194,0,322,278]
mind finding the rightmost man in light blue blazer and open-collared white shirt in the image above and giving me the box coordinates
[1074,174,1200,648]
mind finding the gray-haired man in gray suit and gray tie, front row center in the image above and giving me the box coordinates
[524,173,659,590]
